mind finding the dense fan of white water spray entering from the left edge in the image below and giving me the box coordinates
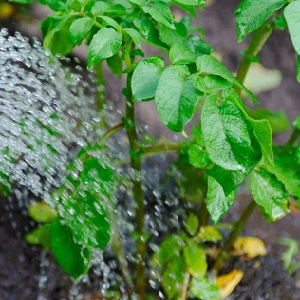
[0,30,97,200]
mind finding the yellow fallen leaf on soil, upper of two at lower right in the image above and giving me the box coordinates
[234,236,267,258]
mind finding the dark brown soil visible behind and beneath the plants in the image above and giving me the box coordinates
[0,0,300,300]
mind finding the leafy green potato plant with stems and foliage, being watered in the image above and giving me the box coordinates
[5,0,300,300]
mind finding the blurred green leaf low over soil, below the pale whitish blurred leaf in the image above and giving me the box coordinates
[247,107,290,133]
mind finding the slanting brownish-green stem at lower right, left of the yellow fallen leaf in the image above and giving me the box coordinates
[212,199,256,272]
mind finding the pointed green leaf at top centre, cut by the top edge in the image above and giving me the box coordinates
[143,1,175,29]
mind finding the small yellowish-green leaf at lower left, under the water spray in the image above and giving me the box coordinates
[28,201,57,223]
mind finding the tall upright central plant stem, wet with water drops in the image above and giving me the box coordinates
[123,48,146,300]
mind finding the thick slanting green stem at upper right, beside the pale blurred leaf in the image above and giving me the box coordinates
[236,23,273,95]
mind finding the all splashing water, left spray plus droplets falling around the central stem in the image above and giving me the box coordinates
[0,30,188,299]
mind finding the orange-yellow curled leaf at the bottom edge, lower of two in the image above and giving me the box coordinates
[216,269,244,299]
